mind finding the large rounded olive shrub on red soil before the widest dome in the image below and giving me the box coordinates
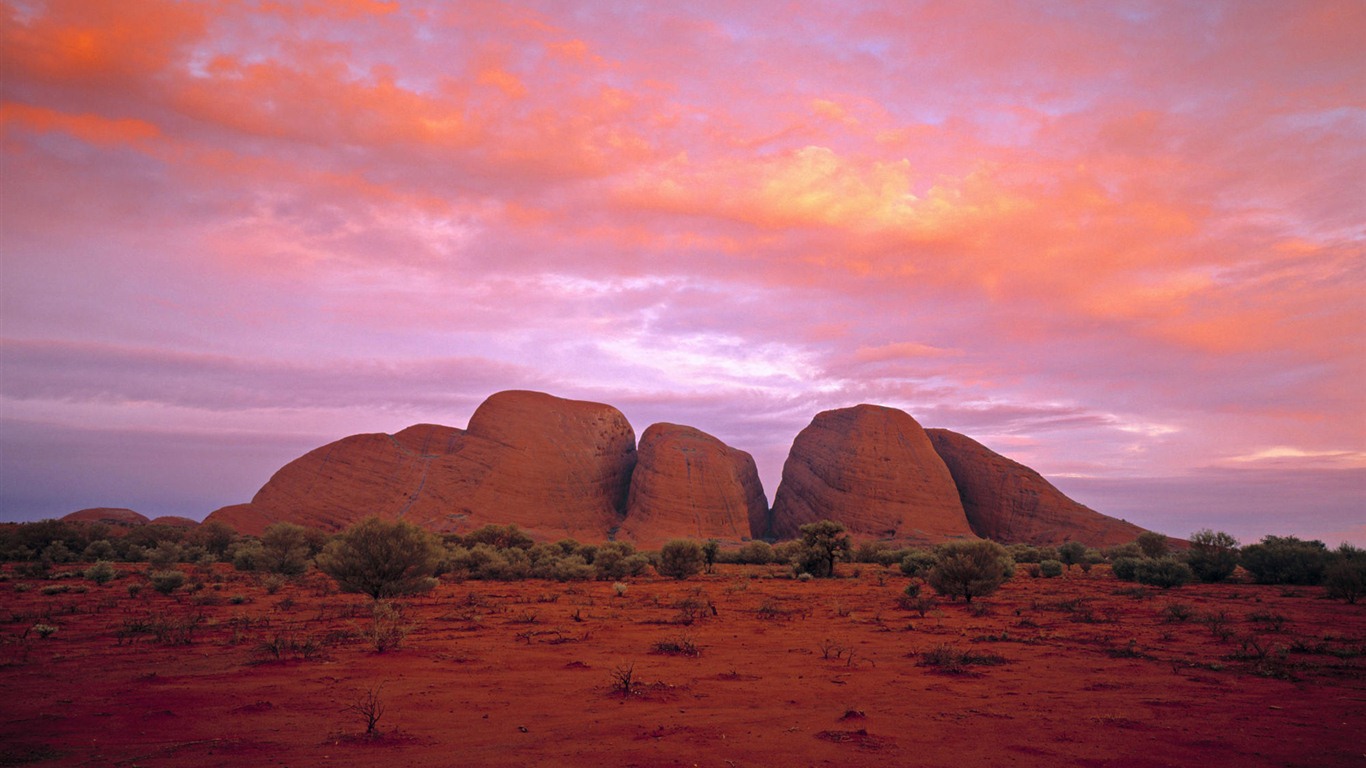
[317,518,441,600]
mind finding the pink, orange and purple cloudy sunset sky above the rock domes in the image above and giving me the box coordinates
[0,0,1366,545]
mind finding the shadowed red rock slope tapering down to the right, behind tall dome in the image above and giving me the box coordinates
[928,429,1143,547]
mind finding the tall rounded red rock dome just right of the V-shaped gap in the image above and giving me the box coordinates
[770,404,974,544]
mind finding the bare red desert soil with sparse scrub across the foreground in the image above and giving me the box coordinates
[0,564,1366,768]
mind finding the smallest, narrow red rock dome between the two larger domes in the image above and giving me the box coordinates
[617,424,768,549]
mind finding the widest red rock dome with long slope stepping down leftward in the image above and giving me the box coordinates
[205,392,635,541]
